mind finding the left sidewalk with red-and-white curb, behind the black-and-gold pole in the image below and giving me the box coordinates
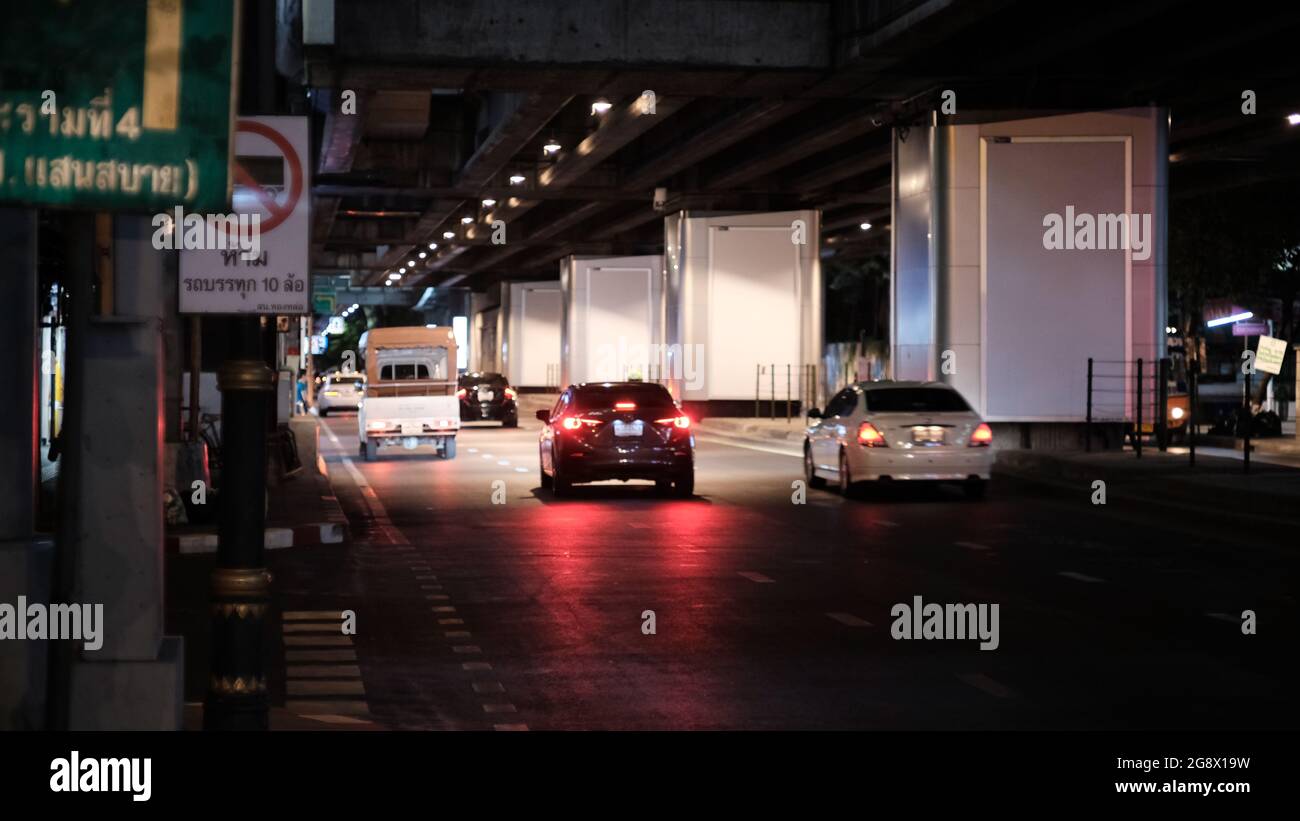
[166,416,347,553]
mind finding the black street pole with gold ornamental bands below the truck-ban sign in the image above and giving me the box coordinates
[203,317,273,730]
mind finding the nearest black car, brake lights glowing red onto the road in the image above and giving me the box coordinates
[537,382,696,498]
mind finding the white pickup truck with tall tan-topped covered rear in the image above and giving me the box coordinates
[356,327,460,461]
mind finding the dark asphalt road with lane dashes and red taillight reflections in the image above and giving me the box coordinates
[287,416,1300,730]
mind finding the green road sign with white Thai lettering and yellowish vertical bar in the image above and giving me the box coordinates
[0,0,237,212]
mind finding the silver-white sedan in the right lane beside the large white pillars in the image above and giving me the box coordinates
[803,381,993,499]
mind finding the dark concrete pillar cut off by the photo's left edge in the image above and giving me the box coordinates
[0,208,53,730]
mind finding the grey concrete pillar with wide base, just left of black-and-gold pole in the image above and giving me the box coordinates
[60,217,185,730]
